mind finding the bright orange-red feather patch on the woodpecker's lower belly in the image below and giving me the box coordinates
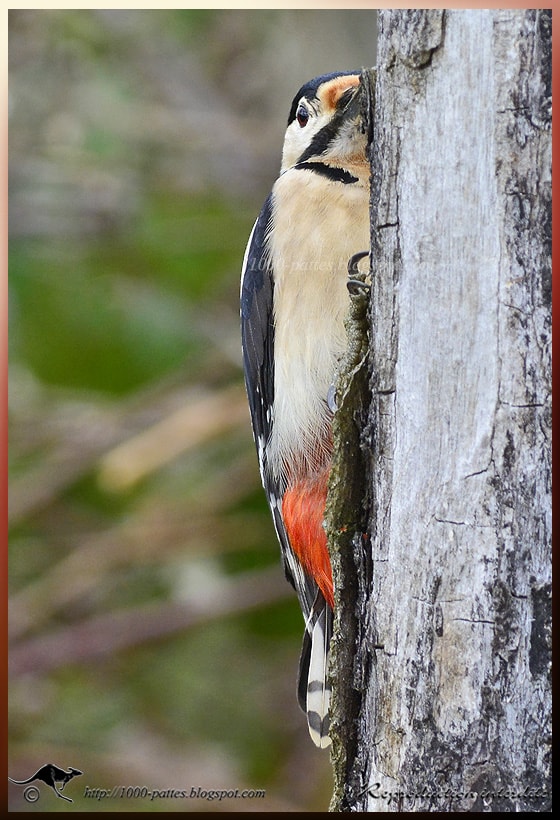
[282,470,334,609]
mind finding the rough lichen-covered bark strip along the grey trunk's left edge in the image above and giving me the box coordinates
[325,69,375,811]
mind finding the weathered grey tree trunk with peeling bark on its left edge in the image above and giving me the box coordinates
[327,9,551,812]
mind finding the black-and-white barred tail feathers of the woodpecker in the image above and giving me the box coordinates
[298,591,333,749]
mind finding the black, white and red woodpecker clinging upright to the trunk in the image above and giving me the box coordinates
[241,71,370,748]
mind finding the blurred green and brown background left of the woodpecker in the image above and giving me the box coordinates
[9,10,376,812]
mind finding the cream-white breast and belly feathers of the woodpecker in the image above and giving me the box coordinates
[268,170,369,479]
